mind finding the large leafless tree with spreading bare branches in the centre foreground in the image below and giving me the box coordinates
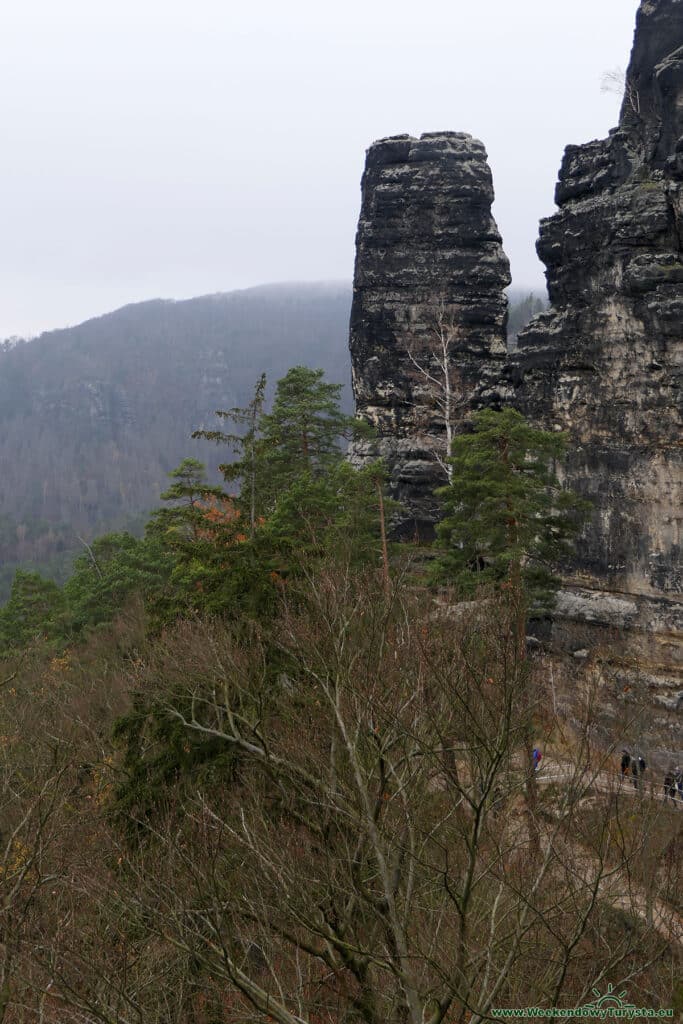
[81,572,679,1024]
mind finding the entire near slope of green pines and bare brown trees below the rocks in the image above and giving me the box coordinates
[0,367,683,1024]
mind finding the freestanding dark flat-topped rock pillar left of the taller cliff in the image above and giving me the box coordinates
[350,132,510,534]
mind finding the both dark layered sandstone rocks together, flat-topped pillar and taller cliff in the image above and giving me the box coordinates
[351,0,683,711]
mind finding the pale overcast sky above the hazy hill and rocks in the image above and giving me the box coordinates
[0,0,638,338]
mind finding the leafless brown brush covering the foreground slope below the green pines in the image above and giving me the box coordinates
[0,568,680,1024]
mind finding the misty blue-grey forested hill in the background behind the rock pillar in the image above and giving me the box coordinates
[0,282,542,600]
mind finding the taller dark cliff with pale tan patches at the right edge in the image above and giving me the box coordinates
[516,0,683,700]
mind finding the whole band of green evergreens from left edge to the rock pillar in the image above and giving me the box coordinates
[0,367,382,645]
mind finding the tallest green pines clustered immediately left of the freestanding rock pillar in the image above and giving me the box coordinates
[179,367,383,616]
